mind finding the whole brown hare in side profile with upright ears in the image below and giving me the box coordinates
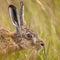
[0,1,44,54]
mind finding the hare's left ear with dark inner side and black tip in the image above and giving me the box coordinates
[8,5,19,32]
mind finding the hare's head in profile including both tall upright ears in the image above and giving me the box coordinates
[9,2,44,50]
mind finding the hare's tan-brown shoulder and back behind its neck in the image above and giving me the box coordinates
[0,28,18,54]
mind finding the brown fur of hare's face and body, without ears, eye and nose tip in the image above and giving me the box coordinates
[0,27,43,54]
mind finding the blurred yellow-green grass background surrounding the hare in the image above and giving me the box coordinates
[0,0,60,60]
